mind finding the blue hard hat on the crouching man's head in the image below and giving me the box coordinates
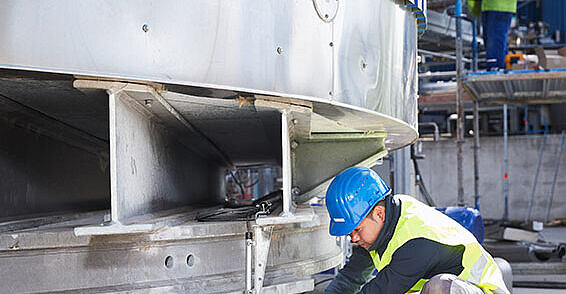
[326,167,391,236]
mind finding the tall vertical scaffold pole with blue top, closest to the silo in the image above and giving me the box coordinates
[456,0,464,206]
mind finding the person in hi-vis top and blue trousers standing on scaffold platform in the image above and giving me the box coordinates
[468,0,517,69]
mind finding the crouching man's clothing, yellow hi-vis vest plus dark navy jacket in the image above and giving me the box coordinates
[324,195,509,294]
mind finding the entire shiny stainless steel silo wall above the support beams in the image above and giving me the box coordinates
[0,0,417,126]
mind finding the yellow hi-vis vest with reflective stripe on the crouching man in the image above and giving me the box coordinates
[370,195,509,294]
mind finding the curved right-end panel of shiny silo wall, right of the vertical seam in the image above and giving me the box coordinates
[333,1,417,128]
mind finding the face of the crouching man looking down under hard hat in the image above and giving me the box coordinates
[350,206,385,250]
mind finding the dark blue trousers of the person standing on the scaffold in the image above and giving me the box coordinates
[481,11,513,69]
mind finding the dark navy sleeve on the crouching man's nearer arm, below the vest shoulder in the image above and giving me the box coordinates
[360,239,463,294]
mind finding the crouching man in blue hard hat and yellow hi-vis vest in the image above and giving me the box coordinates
[324,167,509,294]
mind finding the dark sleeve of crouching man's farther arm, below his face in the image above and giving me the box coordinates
[324,246,375,294]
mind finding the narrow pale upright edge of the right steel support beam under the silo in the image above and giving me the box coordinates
[281,110,293,216]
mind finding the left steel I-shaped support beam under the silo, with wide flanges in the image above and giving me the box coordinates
[75,81,226,235]
